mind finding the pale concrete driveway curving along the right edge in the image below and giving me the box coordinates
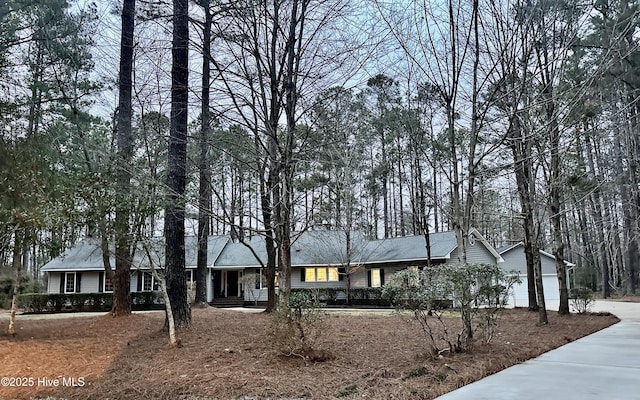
[438,301,640,400]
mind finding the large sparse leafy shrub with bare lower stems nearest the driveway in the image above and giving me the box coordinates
[383,264,519,357]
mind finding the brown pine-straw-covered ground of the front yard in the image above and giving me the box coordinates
[0,308,618,400]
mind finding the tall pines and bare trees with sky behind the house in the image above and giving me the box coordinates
[0,0,640,310]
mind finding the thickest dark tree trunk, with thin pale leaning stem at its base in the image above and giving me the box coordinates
[164,0,191,328]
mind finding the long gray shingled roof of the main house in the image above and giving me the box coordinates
[42,230,500,271]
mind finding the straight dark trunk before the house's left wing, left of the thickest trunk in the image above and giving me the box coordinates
[111,0,135,316]
